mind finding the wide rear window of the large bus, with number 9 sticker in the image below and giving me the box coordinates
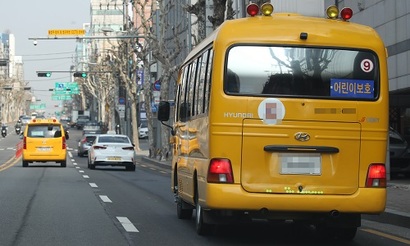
[224,45,379,100]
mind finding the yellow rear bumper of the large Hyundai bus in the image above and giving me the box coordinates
[200,184,387,214]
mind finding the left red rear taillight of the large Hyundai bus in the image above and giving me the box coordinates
[207,159,233,183]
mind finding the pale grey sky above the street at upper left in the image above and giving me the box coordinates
[0,0,90,116]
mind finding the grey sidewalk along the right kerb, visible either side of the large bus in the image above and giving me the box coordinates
[137,153,410,218]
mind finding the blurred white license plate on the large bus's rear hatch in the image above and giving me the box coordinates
[279,153,322,175]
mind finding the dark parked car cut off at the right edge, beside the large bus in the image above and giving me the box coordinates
[389,128,410,174]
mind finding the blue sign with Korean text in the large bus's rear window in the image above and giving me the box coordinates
[330,79,374,98]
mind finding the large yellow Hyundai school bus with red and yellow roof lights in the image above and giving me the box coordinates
[158,4,389,240]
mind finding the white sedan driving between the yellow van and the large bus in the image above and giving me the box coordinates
[88,134,137,171]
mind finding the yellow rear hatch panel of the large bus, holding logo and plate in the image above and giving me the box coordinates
[241,119,360,195]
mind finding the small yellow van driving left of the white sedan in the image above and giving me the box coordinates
[22,119,68,167]
